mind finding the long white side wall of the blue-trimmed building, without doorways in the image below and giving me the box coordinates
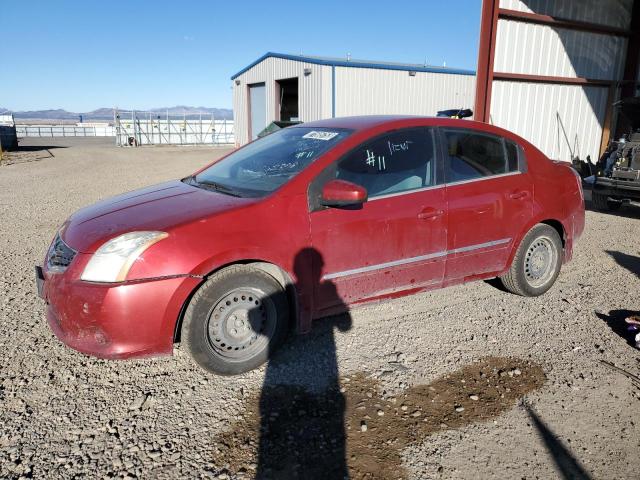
[336,67,475,117]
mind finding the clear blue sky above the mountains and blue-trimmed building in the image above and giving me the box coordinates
[0,0,481,112]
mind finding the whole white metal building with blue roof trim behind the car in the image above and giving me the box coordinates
[231,52,475,145]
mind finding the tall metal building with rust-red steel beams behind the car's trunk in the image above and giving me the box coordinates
[475,0,640,161]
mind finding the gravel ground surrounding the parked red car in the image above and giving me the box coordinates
[0,139,640,479]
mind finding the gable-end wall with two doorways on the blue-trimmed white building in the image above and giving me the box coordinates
[233,57,331,145]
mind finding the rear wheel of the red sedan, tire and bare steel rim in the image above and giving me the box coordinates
[500,223,564,297]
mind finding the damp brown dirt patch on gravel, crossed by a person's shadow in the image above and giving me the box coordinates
[213,357,545,479]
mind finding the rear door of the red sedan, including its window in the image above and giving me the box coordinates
[441,129,533,283]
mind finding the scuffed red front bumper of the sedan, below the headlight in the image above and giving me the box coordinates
[36,262,201,359]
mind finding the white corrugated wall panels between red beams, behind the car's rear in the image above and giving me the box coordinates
[490,0,633,161]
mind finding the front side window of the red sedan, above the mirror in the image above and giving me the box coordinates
[335,127,436,198]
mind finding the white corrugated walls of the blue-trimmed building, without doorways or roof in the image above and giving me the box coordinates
[233,57,475,145]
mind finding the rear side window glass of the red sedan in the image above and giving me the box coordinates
[443,129,519,183]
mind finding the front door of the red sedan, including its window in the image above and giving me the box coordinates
[310,127,447,310]
